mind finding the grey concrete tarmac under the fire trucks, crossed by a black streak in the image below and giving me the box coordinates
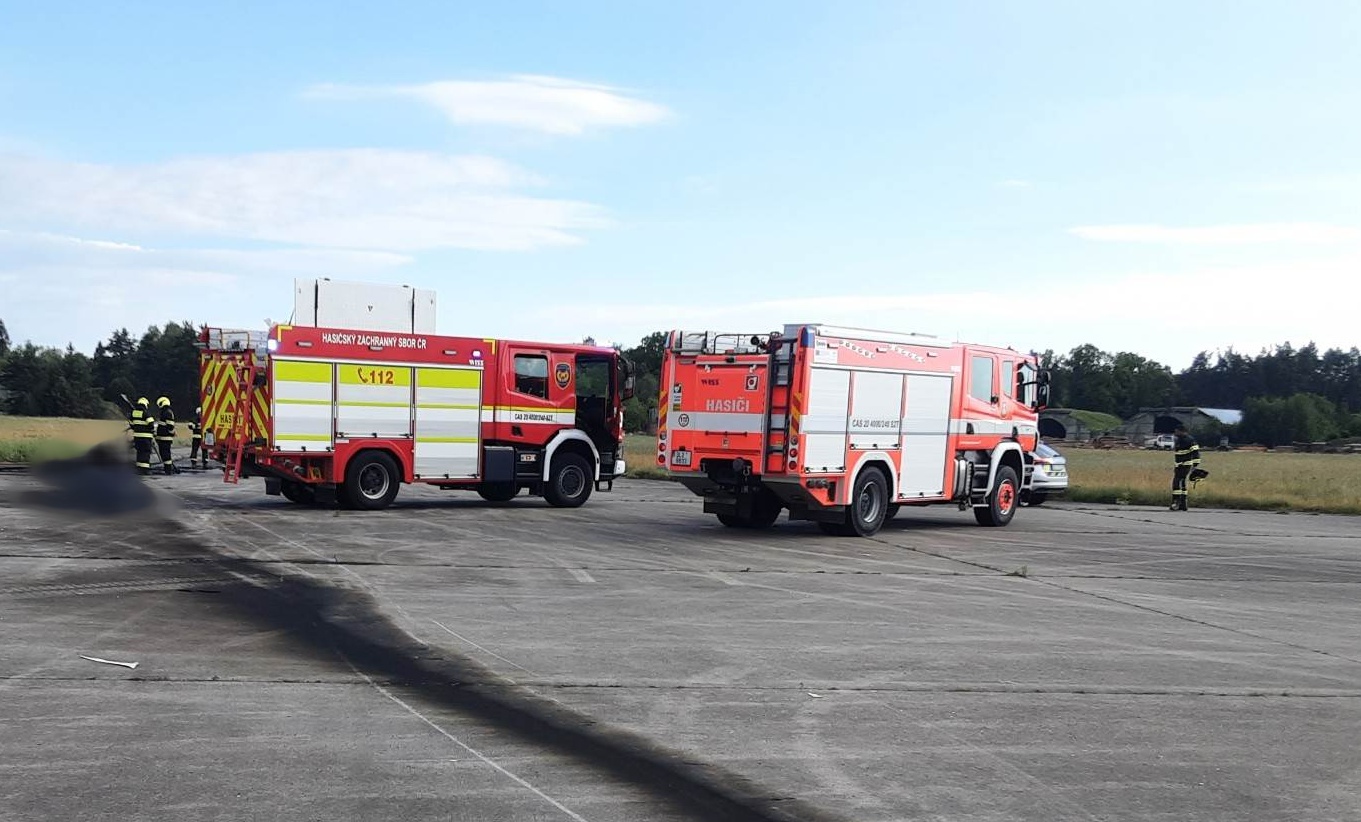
[0,472,1361,822]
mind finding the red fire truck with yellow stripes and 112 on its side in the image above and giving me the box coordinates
[199,325,633,509]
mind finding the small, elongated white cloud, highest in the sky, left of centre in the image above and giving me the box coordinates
[305,75,670,135]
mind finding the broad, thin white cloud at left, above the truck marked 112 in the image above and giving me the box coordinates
[0,150,608,250]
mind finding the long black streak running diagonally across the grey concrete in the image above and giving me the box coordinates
[20,446,838,822]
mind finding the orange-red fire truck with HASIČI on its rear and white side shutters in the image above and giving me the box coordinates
[656,324,1049,536]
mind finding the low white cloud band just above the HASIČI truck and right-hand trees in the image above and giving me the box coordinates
[532,252,1361,370]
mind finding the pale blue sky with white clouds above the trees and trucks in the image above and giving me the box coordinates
[0,1,1361,369]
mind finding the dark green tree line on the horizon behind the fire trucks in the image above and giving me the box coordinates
[0,320,1361,445]
